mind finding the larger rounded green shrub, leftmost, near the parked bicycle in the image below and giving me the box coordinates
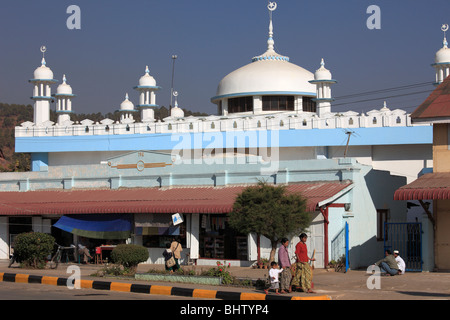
[14,232,55,268]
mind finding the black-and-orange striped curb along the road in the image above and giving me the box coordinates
[0,272,331,300]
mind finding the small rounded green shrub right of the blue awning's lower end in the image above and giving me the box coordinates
[111,244,149,272]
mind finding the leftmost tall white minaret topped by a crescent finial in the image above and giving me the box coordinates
[29,46,58,126]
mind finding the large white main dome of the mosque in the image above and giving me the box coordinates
[213,57,316,99]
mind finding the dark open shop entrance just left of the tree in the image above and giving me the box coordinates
[200,214,248,260]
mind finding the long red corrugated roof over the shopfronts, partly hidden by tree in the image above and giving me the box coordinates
[0,181,352,215]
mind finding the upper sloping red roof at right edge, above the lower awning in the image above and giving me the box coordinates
[411,77,450,120]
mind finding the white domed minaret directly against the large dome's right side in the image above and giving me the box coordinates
[309,59,337,117]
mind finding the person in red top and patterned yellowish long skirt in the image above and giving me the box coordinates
[292,233,316,293]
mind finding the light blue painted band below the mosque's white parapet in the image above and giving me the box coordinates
[15,126,433,153]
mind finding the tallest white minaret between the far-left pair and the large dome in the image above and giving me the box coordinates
[134,66,161,122]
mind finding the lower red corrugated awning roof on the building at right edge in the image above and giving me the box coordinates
[394,172,450,200]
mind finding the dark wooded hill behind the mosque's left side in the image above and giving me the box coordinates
[0,102,208,172]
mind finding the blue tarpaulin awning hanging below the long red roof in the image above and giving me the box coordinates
[53,214,132,239]
